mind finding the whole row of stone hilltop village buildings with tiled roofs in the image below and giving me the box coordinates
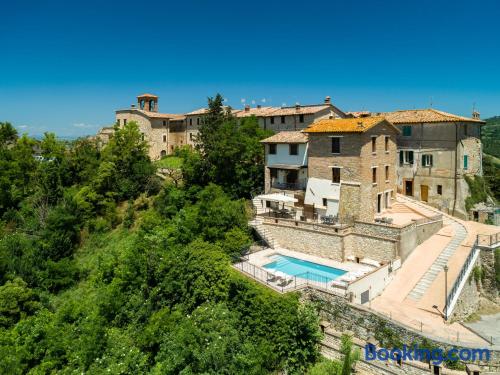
[98,94,484,218]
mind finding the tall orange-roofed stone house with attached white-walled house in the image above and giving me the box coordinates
[262,117,399,222]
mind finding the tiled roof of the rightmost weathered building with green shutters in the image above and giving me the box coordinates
[380,108,485,124]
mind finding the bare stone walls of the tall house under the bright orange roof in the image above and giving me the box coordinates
[306,121,397,221]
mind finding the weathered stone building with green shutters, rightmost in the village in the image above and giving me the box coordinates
[382,109,484,218]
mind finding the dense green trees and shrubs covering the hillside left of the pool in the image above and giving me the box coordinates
[0,110,320,374]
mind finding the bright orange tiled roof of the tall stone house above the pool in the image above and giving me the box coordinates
[303,116,399,133]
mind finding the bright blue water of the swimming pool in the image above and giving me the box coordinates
[264,255,346,282]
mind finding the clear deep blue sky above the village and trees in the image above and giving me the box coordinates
[0,0,500,136]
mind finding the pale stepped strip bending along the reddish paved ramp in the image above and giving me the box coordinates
[398,197,467,301]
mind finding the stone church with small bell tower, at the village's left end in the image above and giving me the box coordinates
[110,94,186,160]
